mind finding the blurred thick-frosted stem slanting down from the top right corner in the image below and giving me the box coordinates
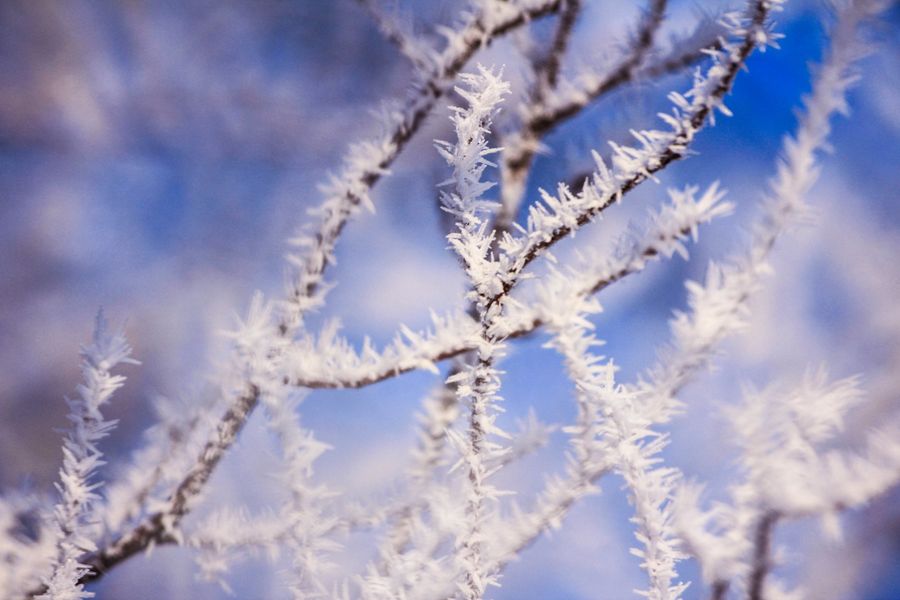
[642,0,883,422]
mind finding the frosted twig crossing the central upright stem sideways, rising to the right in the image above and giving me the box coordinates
[276,187,731,388]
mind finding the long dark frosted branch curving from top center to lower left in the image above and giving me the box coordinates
[68,0,561,582]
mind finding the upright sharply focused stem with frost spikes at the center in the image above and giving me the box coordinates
[437,66,509,600]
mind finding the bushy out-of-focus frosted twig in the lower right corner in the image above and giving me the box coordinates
[676,369,900,600]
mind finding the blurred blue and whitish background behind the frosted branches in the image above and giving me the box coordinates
[0,0,900,600]
